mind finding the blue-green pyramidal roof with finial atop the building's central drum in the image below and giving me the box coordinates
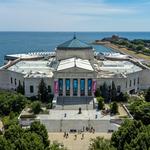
[57,35,93,50]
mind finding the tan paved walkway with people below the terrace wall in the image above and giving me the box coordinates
[48,133,112,150]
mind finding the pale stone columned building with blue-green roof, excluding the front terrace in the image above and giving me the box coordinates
[0,36,150,108]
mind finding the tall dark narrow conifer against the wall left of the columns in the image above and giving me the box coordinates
[38,79,48,102]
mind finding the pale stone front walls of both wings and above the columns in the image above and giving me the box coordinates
[0,66,150,97]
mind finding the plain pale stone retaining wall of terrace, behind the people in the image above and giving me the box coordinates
[40,119,111,132]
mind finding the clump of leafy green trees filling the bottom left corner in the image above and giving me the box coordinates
[0,122,50,150]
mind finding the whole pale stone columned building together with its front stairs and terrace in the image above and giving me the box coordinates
[0,37,150,132]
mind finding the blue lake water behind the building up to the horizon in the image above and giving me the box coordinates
[0,32,150,65]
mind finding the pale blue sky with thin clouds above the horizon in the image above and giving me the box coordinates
[0,0,150,32]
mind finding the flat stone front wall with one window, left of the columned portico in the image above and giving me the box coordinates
[25,78,53,97]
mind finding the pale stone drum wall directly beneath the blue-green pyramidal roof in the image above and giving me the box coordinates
[56,49,94,60]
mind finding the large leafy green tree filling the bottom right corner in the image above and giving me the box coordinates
[111,120,150,150]
